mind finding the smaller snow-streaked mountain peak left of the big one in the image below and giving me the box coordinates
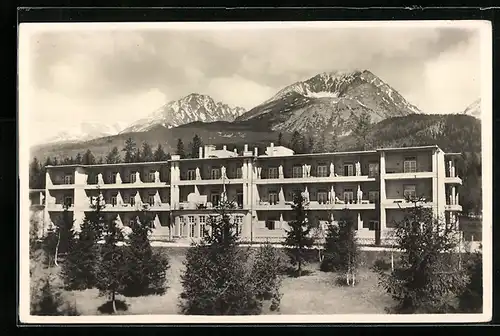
[121,93,245,133]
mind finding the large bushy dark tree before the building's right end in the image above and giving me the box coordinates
[379,199,467,313]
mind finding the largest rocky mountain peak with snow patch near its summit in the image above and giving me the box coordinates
[236,70,421,134]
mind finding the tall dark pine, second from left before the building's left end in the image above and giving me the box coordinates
[61,193,105,290]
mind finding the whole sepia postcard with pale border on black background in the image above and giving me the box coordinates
[18,21,493,324]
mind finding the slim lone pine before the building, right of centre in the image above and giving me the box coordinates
[285,193,314,276]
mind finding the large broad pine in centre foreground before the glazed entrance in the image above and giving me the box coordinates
[180,201,262,315]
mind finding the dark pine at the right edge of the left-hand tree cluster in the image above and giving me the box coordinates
[123,210,170,296]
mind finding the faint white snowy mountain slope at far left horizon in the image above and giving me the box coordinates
[42,122,124,144]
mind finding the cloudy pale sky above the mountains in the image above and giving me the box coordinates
[20,23,482,143]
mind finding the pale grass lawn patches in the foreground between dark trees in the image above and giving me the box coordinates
[55,248,391,315]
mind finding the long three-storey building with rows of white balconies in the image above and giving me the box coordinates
[41,143,462,244]
